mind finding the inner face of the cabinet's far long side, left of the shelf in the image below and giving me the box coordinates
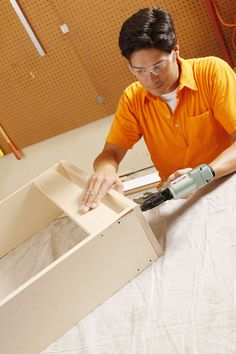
[0,183,62,258]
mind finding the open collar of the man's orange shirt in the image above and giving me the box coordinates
[143,57,198,103]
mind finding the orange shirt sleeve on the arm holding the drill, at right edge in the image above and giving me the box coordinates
[212,58,236,134]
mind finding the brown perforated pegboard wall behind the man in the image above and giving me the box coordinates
[0,0,236,153]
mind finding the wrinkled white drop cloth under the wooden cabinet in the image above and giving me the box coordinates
[0,174,236,354]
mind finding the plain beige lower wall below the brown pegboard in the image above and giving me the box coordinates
[0,116,152,199]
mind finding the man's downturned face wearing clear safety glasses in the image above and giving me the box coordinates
[130,47,179,96]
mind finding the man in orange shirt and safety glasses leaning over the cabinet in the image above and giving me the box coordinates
[81,7,236,212]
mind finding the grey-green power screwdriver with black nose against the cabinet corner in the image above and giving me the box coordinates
[140,164,215,211]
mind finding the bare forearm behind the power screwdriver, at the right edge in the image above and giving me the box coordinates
[210,141,236,178]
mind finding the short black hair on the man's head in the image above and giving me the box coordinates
[119,7,176,60]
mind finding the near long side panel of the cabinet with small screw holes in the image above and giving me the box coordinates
[0,207,158,354]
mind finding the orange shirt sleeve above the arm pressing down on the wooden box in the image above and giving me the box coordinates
[106,91,142,149]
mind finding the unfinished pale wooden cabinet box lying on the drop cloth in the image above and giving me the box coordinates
[0,162,162,354]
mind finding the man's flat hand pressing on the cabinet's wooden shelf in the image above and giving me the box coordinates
[80,167,123,213]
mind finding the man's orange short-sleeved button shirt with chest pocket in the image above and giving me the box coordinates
[106,57,236,180]
